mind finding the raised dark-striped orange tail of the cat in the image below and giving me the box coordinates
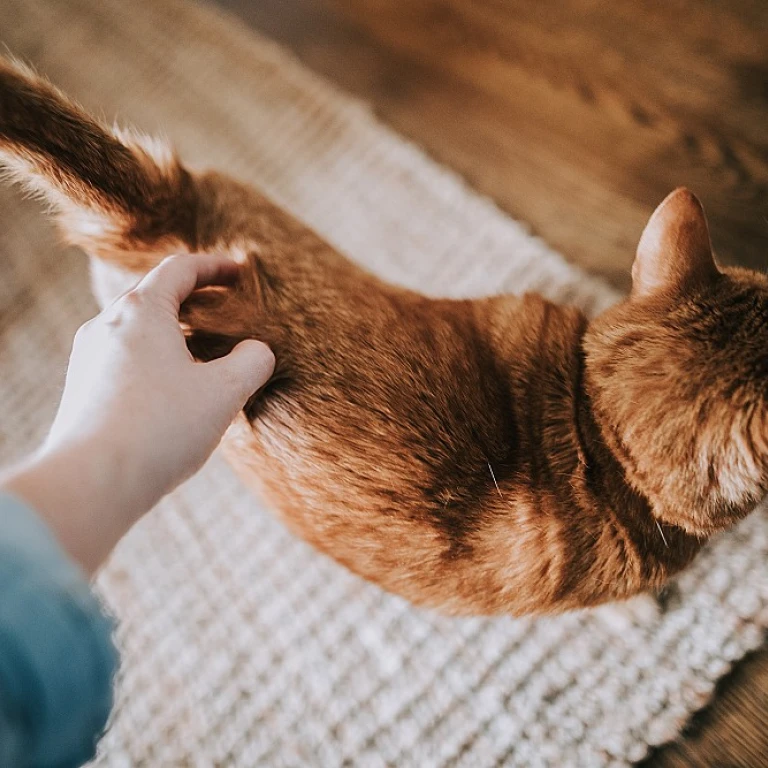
[0,57,198,272]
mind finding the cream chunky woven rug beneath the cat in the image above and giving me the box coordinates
[0,0,768,768]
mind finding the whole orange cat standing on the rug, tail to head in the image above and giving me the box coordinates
[0,57,768,614]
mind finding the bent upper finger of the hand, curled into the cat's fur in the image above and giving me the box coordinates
[135,253,240,311]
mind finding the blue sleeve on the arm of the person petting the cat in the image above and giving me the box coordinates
[0,494,117,768]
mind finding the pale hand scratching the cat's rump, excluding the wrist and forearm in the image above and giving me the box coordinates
[43,256,274,514]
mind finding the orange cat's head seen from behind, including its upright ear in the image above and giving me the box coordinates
[585,189,768,535]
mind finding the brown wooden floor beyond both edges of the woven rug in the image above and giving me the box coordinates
[212,0,768,768]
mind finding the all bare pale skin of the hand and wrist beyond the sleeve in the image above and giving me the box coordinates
[0,255,274,575]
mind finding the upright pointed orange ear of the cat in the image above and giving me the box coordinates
[632,187,720,298]
